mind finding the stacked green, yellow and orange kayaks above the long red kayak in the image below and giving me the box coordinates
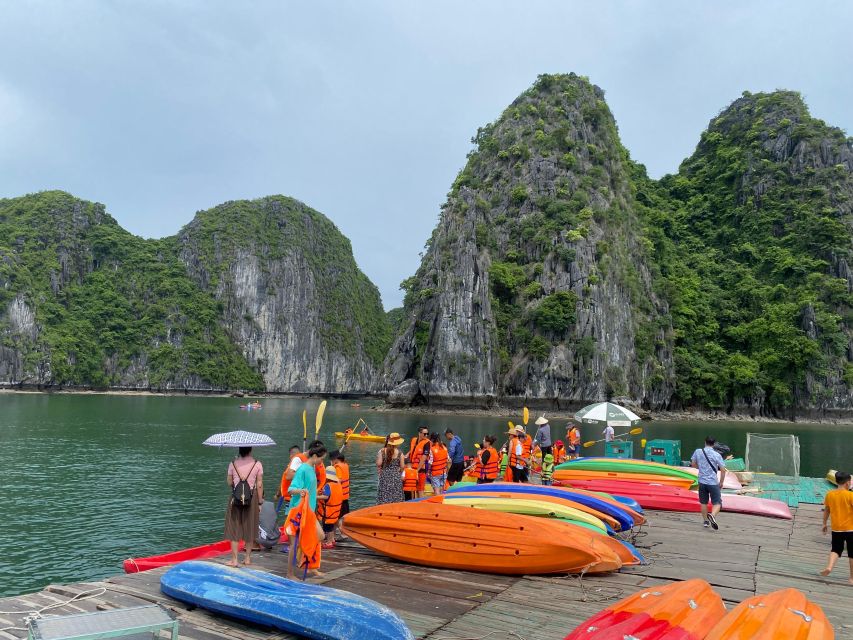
[554,458,696,489]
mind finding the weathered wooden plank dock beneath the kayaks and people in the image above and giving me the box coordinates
[0,504,853,640]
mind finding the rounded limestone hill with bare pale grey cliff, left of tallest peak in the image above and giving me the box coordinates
[178,196,390,393]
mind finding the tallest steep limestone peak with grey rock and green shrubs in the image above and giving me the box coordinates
[385,74,673,406]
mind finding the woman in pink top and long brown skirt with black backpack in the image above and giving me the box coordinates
[225,447,264,567]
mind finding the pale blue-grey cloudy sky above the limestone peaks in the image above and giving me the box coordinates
[0,0,853,309]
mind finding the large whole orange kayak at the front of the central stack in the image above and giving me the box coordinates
[343,502,622,575]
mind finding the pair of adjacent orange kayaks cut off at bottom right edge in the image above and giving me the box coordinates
[565,579,835,640]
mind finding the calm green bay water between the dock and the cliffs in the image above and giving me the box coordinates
[0,393,853,595]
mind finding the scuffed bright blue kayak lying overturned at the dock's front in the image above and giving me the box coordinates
[160,561,414,640]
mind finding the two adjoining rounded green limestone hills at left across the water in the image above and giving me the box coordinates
[0,192,389,393]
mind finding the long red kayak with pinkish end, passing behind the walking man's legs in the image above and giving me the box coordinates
[560,480,793,520]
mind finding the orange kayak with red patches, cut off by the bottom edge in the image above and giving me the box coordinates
[565,578,724,640]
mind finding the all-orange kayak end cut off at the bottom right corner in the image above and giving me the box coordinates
[705,589,835,640]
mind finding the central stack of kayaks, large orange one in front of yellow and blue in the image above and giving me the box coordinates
[343,483,645,575]
